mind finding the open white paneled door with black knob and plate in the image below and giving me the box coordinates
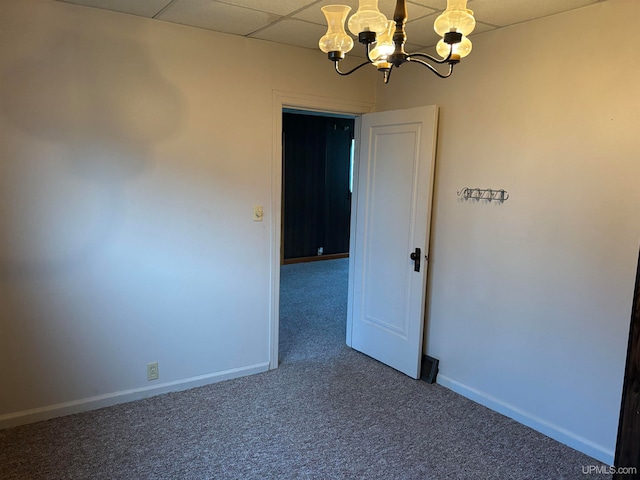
[347,106,438,378]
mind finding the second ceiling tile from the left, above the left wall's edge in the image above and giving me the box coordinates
[156,0,280,35]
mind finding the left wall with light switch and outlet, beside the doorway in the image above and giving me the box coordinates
[0,0,374,427]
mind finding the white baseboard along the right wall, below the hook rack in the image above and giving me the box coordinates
[436,374,614,465]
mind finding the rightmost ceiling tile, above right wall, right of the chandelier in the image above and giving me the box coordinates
[469,0,600,27]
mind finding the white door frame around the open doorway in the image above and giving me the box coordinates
[269,90,374,370]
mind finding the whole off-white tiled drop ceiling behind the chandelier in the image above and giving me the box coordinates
[52,0,606,51]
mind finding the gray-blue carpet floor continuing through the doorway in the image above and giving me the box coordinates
[0,259,610,480]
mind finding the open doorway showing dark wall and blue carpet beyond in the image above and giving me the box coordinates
[278,108,356,363]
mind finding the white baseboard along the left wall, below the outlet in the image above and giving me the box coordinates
[0,362,269,429]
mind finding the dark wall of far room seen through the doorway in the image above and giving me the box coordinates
[281,109,355,265]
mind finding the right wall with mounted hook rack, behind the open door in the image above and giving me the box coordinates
[376,0,640,463]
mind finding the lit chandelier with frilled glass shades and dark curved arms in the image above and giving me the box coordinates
[318,0,476,83]
